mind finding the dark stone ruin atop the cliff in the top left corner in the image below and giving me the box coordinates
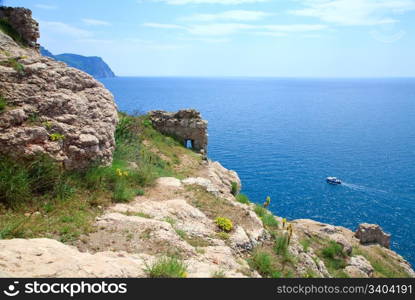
[0,6,40,49]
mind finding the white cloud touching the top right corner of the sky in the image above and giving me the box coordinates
[290,0,415,26]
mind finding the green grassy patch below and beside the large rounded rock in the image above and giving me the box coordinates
[0,114,192,242]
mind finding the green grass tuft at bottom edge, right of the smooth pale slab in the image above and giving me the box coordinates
[145,257,187,278]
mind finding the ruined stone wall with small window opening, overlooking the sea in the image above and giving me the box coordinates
[149,109,208,155]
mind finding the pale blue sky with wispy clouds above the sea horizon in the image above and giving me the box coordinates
[5,0,415,77]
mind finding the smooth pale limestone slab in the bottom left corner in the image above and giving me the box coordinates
[0,239,145,278]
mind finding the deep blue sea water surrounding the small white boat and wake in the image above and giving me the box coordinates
[102,77,415,265]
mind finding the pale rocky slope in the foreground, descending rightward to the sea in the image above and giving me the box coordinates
[0,161,415,278]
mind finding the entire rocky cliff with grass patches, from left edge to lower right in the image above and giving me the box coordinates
[0,7,415,278]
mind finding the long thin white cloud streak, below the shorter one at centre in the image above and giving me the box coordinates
[143,23,327,37]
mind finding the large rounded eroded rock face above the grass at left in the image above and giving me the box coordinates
[0,16,118,169]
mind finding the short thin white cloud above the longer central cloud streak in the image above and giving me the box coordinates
[181,10,272,22]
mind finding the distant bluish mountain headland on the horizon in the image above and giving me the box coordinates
[40,47,115,78]
